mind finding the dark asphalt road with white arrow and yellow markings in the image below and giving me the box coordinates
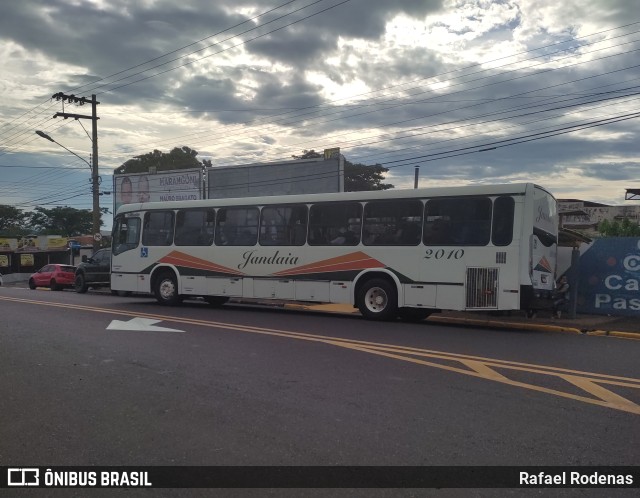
[0,287,640,494]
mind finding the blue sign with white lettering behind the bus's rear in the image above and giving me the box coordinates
[577,237,640,316]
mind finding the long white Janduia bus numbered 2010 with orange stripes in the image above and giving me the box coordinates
[111,183,558,320]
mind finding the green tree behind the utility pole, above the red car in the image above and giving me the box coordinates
[29,206,107,237]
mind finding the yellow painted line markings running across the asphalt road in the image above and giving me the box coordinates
[0,296,640,415]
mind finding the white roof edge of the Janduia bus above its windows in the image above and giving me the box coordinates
[117,183,553,214]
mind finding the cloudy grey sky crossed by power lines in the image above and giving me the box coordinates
[0,0,640,226]
